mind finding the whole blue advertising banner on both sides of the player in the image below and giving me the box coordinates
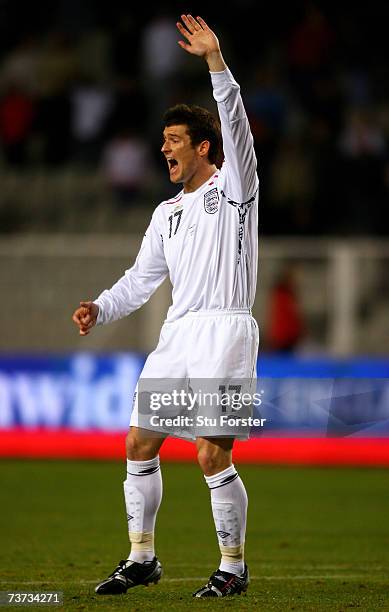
[0,353,389,437]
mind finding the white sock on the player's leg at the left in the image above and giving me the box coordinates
[123,456,162,563]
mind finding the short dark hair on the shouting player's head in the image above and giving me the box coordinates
[163,104,223,168]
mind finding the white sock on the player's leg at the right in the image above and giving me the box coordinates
[204,465,247,575]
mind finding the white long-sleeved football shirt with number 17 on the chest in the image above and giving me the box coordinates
[95,69,258,324]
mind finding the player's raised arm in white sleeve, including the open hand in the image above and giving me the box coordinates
[177,15,258,202]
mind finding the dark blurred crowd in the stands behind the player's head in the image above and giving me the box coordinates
[0,0,389,235]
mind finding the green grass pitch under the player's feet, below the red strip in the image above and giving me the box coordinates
[0,460,389,612]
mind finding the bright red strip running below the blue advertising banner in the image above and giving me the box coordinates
[0,429,389,467]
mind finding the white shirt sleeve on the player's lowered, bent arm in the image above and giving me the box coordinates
[94,209,168,325]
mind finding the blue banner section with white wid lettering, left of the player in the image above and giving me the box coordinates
[0,353,144,431]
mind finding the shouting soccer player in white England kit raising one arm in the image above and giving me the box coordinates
[73,15,258,597]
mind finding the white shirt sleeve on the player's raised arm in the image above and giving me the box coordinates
[210,68,258,202]
